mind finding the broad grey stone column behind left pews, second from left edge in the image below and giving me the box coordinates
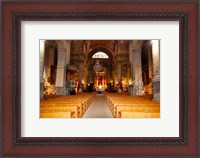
[56,41,70,95]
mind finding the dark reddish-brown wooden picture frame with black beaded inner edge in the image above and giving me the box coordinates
[1,0,200,157]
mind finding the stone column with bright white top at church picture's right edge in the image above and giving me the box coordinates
[152,40,160,102]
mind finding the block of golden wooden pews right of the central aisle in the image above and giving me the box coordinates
[105,93,160,118]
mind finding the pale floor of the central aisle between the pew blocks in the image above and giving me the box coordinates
[82,94,113,118]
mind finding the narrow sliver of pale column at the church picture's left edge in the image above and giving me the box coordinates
[40,40,45,99]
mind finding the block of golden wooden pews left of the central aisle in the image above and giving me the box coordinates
[40,93,96,118]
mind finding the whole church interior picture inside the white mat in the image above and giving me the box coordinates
[40,40,160,118]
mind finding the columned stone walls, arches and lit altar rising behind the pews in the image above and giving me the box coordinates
[40,40,160,103]
